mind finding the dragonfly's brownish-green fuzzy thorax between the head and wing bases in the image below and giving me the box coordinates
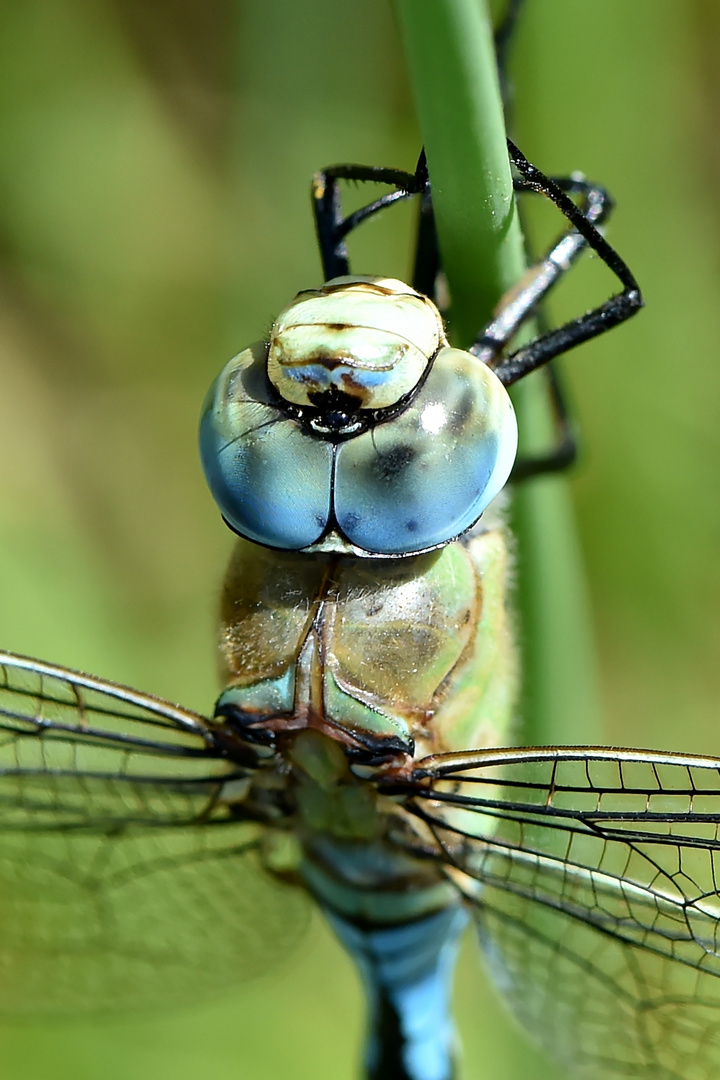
[215,503,515,757]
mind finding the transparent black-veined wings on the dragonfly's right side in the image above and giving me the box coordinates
[399,747,720,1080]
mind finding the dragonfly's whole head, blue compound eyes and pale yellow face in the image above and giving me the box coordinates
[200,279,517,556]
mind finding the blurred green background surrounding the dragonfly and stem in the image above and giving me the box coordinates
[0,0,720,1080]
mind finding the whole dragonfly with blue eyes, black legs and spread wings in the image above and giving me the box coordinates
[0,113,720,1080]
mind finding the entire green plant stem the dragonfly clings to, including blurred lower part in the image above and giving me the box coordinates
[396,0,601,742]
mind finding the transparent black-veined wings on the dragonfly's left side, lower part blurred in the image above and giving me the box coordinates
[0,653,307,1014]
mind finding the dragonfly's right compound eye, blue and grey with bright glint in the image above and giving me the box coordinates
[334,348,517,555]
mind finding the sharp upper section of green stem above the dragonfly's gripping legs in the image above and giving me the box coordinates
[397,0,525,347]
